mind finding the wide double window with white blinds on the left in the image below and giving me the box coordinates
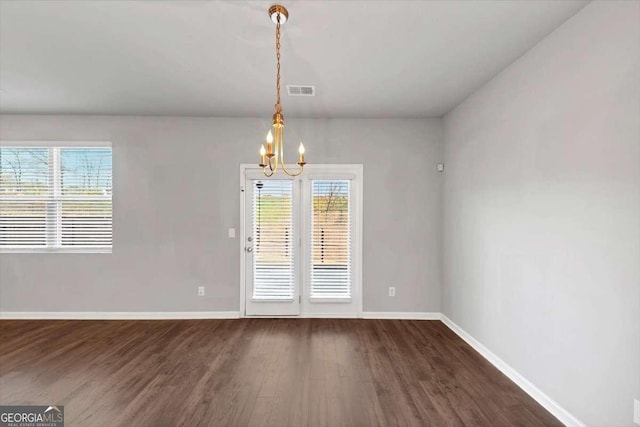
[0,144,112,252]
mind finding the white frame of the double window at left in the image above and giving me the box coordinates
[0,140,113,254]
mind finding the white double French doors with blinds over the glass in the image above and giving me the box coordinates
[241,165,362,317]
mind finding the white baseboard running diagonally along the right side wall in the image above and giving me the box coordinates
[441,314,586,427]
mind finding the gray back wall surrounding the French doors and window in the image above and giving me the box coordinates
[0,115,442,312]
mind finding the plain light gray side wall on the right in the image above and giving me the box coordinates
[443,1,640,427]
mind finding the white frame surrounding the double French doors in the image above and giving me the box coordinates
[238,163,364,318]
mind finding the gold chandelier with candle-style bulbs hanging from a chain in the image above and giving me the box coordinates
[259,4,306,176]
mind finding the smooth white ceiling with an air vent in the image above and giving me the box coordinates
[0,0,586,117]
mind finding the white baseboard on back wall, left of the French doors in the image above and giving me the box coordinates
[0,311,240,320]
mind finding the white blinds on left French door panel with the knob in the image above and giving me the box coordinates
[252,180,294,300]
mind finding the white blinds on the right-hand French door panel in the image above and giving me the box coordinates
[310,180,351,298]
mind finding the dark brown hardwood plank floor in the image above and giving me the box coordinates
[0,319,562,427]
